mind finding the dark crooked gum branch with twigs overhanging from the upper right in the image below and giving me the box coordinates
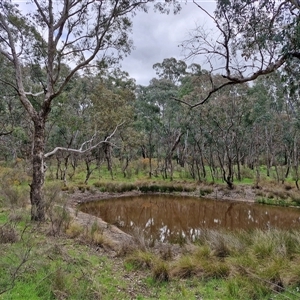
[180,0,300,108]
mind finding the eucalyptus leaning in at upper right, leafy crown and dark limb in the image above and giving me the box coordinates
[182,0,300,107]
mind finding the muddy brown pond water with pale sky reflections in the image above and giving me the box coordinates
[79,195,300,242]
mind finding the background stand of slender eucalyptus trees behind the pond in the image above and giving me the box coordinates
[1,58,300,188]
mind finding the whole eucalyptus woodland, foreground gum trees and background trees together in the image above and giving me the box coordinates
[0,0,300,220]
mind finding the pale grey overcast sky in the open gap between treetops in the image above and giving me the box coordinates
[122,0,215,85]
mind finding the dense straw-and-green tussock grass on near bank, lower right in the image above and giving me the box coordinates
[171,230,300,299]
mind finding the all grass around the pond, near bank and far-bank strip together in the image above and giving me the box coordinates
[0,166,300,300]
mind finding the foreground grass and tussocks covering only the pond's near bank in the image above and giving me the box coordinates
[0,207,300,300]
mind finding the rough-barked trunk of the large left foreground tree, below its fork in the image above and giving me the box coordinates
[30,119,45,221]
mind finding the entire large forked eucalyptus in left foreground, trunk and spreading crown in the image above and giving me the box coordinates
[0,0,178,221]
